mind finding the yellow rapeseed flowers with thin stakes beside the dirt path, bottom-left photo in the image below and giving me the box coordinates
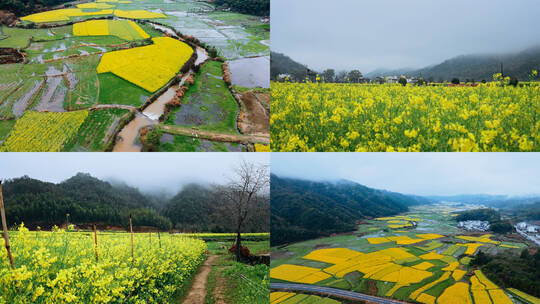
[0,224,206,303]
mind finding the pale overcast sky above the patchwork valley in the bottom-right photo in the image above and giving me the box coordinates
[271,152,540,195]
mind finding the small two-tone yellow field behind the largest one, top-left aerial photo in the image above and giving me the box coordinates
[73,20,150,40]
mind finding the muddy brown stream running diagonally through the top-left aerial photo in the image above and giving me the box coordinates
[113,47,209,152]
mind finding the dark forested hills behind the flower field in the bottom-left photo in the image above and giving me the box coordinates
[2,173,270,232]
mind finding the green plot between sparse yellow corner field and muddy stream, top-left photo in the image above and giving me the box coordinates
[63,109,129,151]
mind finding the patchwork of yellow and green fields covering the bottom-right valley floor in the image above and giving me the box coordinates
[270,206,539,304]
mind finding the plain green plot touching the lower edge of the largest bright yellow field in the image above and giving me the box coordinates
[97,72,151,107]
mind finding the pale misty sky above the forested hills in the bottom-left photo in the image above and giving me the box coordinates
[0,152,270,194]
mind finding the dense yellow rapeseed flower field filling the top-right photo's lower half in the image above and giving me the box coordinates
[271,82,540,152]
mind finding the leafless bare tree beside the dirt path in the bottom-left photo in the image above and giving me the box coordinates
[220,160,270,261]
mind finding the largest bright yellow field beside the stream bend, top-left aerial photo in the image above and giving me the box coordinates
[97,37,193,92]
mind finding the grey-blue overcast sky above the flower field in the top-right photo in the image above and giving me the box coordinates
[271,0,540,73]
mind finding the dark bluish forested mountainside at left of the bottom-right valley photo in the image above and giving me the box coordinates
[270,175,431,246]
